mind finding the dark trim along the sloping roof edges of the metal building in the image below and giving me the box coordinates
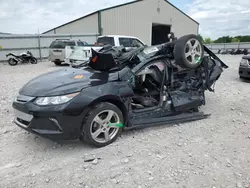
[42,0,199,34]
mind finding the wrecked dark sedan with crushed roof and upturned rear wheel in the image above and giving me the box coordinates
[13,35,227,147]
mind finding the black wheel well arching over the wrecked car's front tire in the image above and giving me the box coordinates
[90,98,128,125]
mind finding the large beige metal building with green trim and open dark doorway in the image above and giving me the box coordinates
[44,0,199,45]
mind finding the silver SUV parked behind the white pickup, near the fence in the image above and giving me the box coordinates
[48,39,88,65]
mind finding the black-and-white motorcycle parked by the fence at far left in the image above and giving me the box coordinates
[6,51,37,66]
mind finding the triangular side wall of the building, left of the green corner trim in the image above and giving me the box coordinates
[45,13,98,34]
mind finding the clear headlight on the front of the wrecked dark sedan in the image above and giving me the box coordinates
[35,92,79,106]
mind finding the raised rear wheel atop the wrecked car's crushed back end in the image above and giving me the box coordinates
[174,35,204,68]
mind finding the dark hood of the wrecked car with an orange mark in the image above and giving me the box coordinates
[19,68,119,97]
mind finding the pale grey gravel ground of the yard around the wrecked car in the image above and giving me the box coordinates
[0,56,250,188]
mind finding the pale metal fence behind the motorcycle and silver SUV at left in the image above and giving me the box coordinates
[0,34,98,62]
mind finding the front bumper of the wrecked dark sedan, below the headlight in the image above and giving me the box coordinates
[12,95,84,140]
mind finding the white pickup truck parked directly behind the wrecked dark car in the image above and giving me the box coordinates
[64,35,145,65]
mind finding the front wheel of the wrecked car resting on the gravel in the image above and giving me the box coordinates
[80,102,124,147]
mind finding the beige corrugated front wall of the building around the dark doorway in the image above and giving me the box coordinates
[101,0,199,45]
